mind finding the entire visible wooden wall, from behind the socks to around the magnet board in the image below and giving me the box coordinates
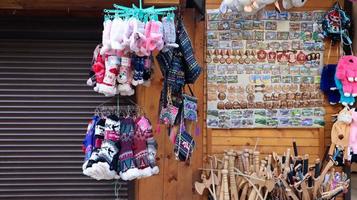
[136,0,338,200]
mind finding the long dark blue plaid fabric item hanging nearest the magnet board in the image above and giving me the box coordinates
[177,19,202,84]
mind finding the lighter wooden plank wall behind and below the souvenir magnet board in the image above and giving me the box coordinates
[206,0,339,160]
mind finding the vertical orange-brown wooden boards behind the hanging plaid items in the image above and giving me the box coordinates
[136,7,205,200]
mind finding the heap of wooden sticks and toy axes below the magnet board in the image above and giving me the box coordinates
[195,142,350,200]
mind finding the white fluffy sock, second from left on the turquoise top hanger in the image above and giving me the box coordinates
[110,18,125,49]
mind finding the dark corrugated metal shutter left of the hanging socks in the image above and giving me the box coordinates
[0,39,133,200]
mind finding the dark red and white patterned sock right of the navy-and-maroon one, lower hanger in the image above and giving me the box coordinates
[133,117,152,178]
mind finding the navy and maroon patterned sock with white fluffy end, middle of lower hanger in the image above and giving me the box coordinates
[118,118,140,181]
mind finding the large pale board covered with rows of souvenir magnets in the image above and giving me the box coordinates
[206,10,325,128]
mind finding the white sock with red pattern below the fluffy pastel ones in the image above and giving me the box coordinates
[117,56,135,96]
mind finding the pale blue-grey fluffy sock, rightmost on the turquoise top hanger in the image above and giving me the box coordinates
[162,17,179,51]
